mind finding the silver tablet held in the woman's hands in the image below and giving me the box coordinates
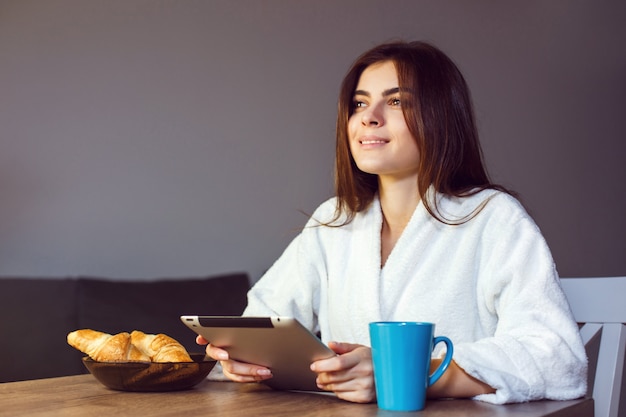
[180,316,335,391]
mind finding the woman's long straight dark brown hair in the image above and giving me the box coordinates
[331,41,511,224]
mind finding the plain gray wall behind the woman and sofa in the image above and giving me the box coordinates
[0,0,626,279]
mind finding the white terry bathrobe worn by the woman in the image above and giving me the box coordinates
[244,190,587,404]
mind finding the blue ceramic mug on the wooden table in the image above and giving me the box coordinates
[369,321,453,411]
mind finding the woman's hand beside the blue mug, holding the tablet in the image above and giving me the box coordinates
[311,342,376,403]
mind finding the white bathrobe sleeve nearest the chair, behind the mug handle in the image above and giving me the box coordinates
[454,197,587,404]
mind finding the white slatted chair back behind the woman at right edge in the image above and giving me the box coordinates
[561,277,626,417]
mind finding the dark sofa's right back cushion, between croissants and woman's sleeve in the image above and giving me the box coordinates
[78,273,250,352]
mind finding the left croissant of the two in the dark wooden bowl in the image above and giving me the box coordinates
[67,329,150,362]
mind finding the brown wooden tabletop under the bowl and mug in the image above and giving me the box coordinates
[0,375,593,417]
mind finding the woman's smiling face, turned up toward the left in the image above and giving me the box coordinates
[348,61,419,179]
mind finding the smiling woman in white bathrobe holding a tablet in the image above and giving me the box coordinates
[198,42,587,403]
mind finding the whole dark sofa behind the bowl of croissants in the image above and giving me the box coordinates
[0,273,250,382]
